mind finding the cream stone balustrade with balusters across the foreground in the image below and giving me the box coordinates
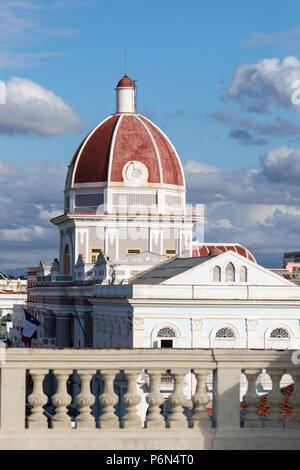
[0,348,300,450]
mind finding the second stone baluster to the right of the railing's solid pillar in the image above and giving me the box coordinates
[267,369,284,428]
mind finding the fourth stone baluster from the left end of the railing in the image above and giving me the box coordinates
[99,369,119,429]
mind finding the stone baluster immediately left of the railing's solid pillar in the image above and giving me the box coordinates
[192,369,210,429]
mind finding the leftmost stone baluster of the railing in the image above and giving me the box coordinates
[28,369,48,429]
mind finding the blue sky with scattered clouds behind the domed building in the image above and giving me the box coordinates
[0,0,300,270]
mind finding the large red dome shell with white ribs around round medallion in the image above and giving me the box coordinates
[67,113,185,189]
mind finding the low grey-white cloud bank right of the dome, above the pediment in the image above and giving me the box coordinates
[184,151,300,267]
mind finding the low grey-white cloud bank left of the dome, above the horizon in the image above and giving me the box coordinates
[0,160,63,269]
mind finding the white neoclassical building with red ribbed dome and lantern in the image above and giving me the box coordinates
[30,76,300,349]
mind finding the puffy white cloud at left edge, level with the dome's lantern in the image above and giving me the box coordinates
[0,77,83,136]
